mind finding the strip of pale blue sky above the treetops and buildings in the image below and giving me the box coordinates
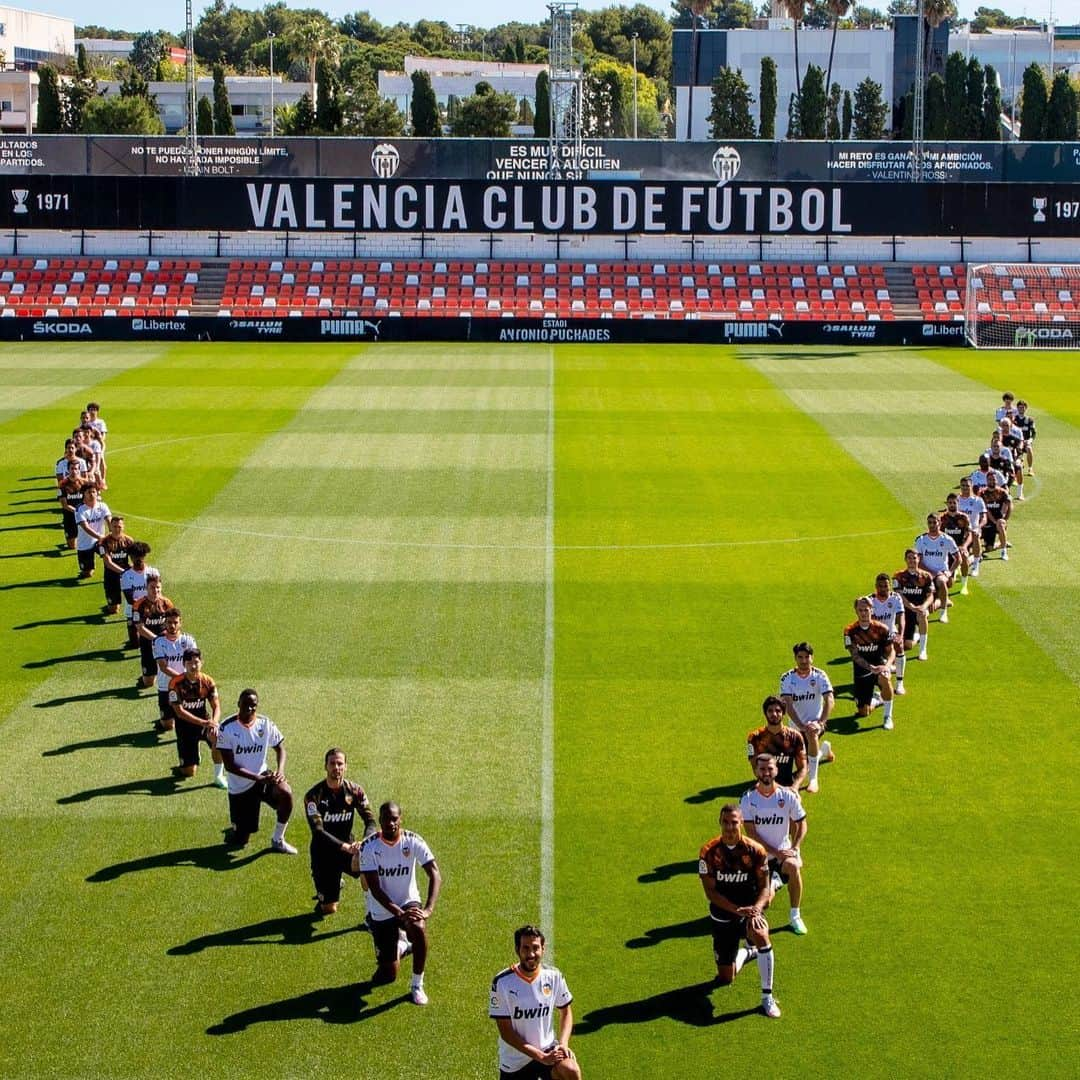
[29,0,1080,33]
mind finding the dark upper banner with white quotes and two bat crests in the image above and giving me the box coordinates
[6,135,1080,185]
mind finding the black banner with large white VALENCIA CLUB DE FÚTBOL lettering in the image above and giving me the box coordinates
[0,176,1080,238]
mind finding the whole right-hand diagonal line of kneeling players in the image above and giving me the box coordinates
[698,393,1036,1018]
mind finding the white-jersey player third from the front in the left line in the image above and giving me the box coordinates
[217,690,296,855]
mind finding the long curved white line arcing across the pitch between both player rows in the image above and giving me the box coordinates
[116,511,915,559]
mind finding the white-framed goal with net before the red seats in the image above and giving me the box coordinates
[963,262,1080,349]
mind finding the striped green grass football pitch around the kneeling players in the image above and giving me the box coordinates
[0,343,1080,1080]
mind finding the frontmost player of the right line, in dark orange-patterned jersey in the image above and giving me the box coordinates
[698,803,781,1020]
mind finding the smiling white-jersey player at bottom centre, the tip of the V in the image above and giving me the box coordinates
[487,926,581,1080]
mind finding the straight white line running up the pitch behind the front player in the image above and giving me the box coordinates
[540,346,555,955]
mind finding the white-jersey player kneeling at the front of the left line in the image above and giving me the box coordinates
[353,802,443,1005]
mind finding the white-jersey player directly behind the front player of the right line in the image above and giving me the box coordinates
[739,754,807,934]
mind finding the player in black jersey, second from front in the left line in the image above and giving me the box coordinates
[303,746,378,915]
